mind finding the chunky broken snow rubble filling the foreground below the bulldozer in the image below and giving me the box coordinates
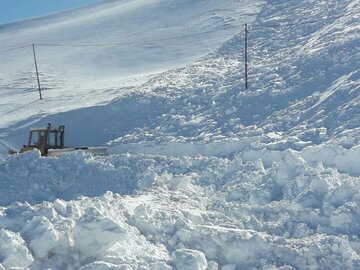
[0,148,359,269]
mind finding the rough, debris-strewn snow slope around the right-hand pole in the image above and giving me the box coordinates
[100,1,360,148]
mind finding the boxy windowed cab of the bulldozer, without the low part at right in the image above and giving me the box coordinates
[20,124,65,156]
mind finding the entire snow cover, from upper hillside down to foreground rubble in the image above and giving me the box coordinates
[0,0,360,270]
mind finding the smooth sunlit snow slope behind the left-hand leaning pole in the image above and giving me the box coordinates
[0,0,264,130]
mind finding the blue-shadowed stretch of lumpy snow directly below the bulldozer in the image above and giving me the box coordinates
[0,150,162,205]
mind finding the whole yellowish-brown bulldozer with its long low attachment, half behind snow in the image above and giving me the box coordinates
[9,124,108,156]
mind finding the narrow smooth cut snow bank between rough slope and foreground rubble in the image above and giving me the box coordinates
[109,135,360,176]
